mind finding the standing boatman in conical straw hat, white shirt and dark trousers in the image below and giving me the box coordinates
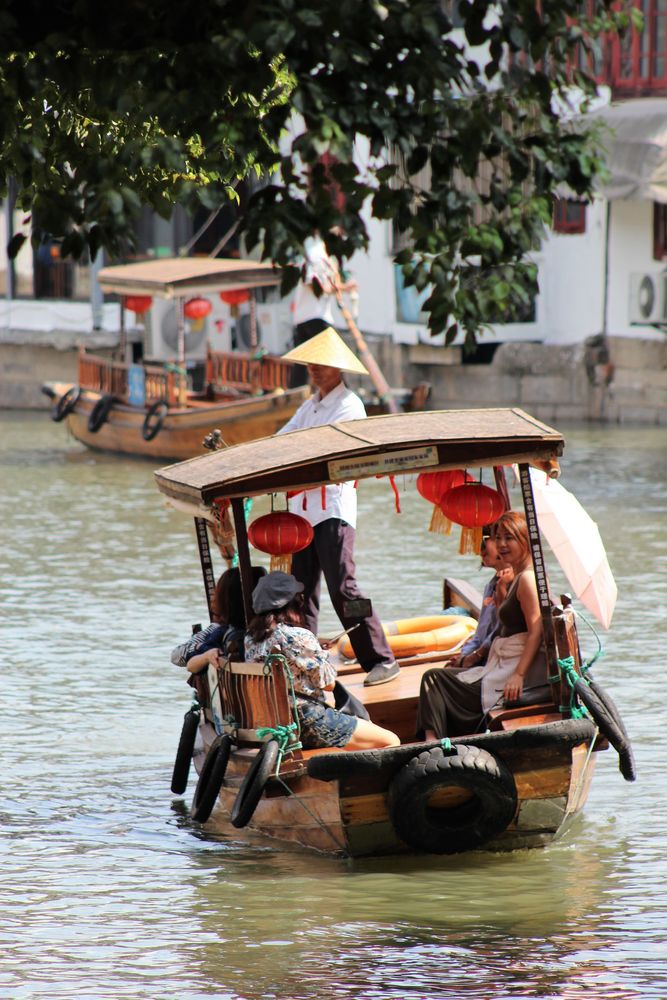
[278,327,400,685]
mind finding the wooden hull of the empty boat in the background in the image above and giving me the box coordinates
[45,383,309,461]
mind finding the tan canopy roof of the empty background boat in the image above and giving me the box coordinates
[97,257,282,299]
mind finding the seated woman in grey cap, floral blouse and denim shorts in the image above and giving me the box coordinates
[245,572,400,750]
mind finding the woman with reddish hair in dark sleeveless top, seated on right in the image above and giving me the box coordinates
[417,511,547,740]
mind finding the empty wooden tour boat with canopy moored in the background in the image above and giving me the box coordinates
[42,258,308,461]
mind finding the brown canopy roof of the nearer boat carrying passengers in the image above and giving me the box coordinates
[155,409,564,516]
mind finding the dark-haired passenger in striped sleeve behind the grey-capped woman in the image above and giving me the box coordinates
[171,566,266,674]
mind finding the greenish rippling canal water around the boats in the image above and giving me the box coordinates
[0,413,667,1000]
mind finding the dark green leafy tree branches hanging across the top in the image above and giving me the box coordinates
[0,0,628,339]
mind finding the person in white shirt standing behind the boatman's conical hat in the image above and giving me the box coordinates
[290,231,357,389]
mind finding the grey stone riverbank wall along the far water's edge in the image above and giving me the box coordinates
[0,331,667,426]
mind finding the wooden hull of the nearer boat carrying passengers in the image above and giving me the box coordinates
[195,723,603,857]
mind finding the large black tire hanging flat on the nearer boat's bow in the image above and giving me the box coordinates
[387,744,518,854]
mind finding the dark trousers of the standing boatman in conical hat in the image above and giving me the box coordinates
[292,517,395,672]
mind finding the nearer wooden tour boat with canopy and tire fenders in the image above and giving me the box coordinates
[155,409,635,856]
